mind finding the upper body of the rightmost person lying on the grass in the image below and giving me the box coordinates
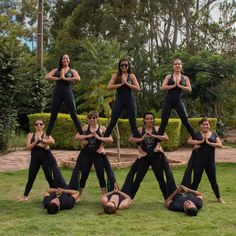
[165,185,203,216]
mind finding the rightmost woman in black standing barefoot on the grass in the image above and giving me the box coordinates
[188,117,224,203]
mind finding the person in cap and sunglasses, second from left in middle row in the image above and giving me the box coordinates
[75,111,115,195]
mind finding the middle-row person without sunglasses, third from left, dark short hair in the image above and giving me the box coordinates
[128,112,175,199]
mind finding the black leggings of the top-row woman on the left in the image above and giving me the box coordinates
[46,89,83,136]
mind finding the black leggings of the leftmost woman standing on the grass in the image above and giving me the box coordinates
[24,150,54,196]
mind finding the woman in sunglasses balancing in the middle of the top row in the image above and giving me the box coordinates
[104,59,140,137]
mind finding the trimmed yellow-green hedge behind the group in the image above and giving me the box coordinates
[28,113,216,150]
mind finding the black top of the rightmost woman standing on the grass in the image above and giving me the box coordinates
[195,132,218,162]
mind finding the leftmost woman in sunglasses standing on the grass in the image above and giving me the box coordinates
[21,119,54,201]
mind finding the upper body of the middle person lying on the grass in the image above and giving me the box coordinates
[101,190,131,214]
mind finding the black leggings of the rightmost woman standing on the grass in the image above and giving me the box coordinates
[192,159,220,198]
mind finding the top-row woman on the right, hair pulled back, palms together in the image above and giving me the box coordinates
[158,58,194,138]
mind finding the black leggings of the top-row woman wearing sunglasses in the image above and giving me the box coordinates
[104,98,140,137]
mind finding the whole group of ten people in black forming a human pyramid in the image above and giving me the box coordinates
[19,54,224,215]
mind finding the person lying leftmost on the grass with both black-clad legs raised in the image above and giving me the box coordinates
[43,151,80,214]
